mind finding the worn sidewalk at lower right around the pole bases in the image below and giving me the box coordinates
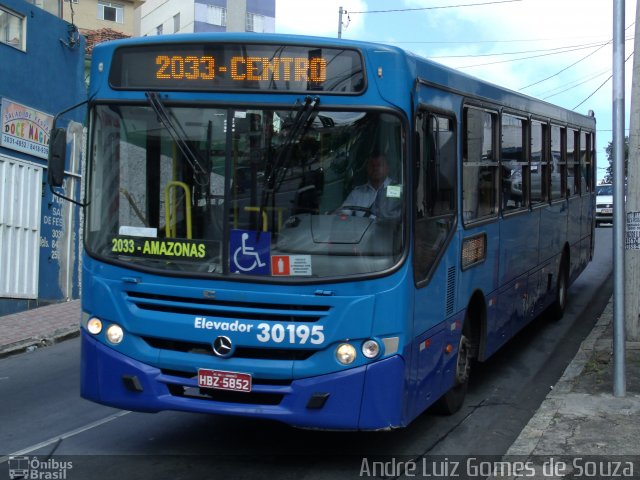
[505,300,640,470]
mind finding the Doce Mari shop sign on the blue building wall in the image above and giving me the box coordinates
[0,98,53,159]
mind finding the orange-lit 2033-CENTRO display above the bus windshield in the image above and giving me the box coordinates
[109,43,364,94]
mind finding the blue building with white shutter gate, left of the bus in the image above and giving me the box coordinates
[0,0,86,321]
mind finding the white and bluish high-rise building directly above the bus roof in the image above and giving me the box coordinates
[140,0,276,36]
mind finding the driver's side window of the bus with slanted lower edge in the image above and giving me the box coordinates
[414,114,456,283]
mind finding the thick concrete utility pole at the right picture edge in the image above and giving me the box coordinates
[625,0,640,342]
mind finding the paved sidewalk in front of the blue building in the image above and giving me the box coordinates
[0,300,80,358]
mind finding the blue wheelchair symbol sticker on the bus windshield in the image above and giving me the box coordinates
[229,230,271,275]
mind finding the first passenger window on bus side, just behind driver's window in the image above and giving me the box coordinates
[462,108,498,223]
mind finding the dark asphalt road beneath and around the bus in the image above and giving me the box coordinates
[0,228,612,480]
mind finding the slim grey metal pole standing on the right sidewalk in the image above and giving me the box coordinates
[613,0,635,397]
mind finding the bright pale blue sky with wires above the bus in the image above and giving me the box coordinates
[276,0,640,181]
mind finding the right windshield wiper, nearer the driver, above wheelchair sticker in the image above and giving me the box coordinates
[258,96,320,227]
